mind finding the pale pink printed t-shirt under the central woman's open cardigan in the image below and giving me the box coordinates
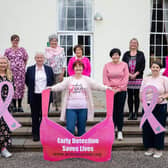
[67,78,88,109]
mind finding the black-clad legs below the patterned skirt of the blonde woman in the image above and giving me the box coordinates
[127,89,140,113]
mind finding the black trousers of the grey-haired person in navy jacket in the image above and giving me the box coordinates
[30,93,42,138]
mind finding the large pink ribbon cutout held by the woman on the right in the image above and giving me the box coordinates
[140,85,165,134]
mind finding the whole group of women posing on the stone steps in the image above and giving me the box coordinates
[0,35,168,158]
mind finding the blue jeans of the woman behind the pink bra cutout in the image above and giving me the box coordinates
[66,109,88,136]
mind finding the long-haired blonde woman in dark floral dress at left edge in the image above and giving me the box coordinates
[0,56,12,158]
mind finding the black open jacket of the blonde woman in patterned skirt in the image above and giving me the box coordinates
[122,51,145,78]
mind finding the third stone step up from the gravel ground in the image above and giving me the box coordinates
[16,116,168,126]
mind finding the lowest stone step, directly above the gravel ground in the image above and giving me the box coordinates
[11,137,168,152]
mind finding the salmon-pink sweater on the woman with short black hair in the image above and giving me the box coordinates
[103,62,129,91]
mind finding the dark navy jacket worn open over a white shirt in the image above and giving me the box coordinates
[26,65,54,104]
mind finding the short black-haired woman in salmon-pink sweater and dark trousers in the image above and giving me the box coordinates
[103,48,129,140]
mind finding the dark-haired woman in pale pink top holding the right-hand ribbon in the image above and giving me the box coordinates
[140,61,168,158]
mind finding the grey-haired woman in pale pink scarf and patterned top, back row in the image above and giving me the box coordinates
[45,34,66,111]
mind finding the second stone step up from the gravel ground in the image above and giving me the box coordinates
[12,126,168,138]
